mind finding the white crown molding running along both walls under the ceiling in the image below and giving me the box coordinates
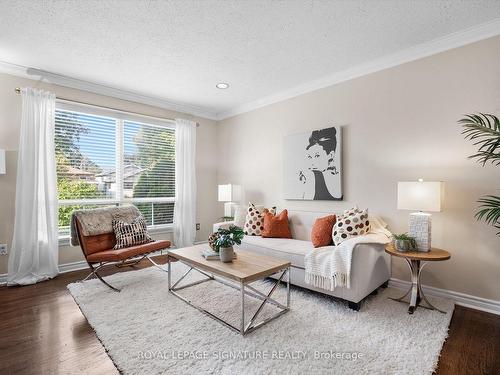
[0,18,500,121]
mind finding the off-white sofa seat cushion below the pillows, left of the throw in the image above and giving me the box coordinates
[240,236,322,268]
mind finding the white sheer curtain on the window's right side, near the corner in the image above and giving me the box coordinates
[174,119,196,247]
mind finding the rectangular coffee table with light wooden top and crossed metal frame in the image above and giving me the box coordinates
[167,244,290,335]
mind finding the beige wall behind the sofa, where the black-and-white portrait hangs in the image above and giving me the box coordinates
[217,37,500,300]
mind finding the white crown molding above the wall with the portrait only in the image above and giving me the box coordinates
[217,18,500,120]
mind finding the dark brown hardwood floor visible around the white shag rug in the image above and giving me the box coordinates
[0,257,500,375]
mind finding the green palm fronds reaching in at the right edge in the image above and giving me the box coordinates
[458,113,500,236]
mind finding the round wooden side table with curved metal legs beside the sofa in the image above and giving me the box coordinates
[385,243,451,314]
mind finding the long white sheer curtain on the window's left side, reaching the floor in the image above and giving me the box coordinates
[7,88,59,285]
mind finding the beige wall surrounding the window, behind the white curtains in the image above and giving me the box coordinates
[0,74,218,274]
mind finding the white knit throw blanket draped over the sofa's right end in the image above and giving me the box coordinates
[305,228,391,290]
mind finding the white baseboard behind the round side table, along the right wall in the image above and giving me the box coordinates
[389,278,500,315]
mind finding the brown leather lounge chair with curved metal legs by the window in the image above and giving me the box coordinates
[74,217,171,292]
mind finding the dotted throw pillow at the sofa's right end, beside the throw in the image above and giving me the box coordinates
[332,207,370,245]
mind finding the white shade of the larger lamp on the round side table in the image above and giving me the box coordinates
[398,181,444,212]
